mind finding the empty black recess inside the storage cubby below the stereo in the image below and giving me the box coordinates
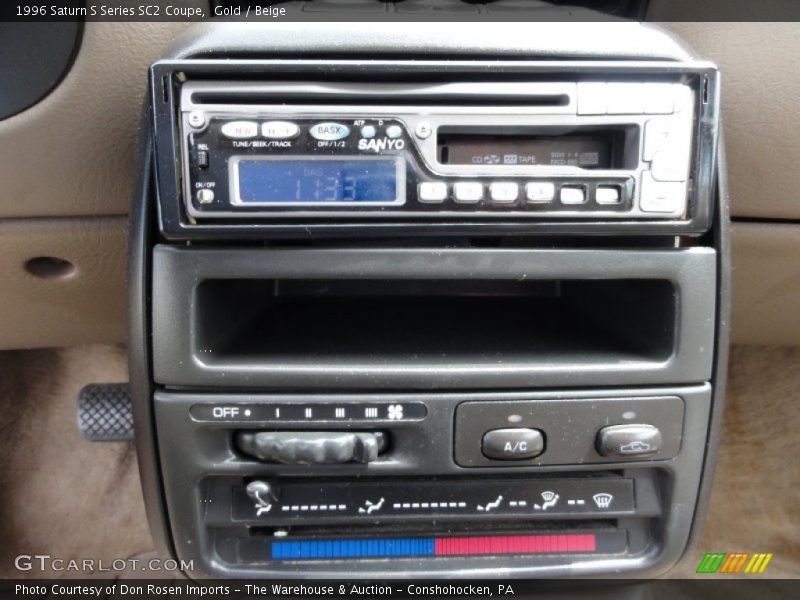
[194,279,677,369]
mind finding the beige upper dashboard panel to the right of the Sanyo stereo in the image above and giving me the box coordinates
[650,22,800,223]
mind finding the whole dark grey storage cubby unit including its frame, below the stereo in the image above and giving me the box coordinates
[153,246,715,391]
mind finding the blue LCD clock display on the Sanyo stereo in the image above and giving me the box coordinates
[238,159,398,204]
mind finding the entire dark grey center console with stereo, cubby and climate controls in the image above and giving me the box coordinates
[129,24,729,578]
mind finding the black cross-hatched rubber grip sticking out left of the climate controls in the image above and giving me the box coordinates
[78,383,133,442]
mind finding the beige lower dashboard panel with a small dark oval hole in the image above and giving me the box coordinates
[0,217,128,349]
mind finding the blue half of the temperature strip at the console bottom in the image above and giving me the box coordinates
[272,538,436,560]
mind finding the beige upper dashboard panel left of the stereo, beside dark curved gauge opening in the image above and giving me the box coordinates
[0,22,188,219]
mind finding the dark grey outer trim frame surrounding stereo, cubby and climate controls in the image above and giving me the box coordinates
[129,23,730,578]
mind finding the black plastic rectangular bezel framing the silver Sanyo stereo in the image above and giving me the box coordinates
[150,60,718,240]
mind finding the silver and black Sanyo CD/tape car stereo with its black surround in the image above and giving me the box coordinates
[154,61,716,235]
